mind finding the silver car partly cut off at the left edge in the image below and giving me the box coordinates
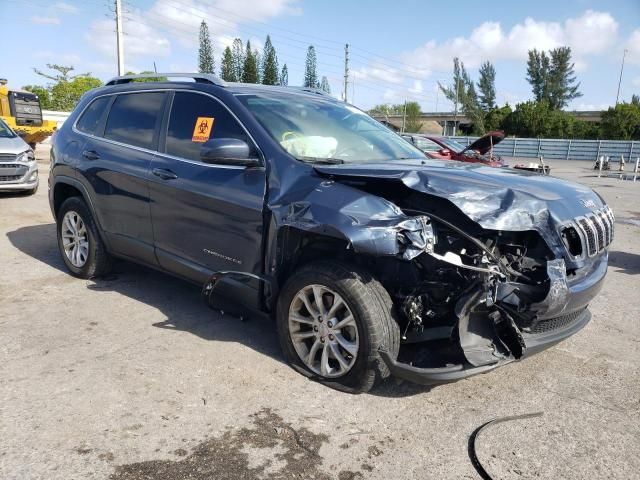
[0,118,38,195]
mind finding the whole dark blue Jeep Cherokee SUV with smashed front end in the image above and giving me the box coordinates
[49,74,614,392]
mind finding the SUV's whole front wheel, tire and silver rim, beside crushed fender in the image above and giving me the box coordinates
[277,262,400,393]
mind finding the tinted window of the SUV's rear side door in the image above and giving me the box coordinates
[104,92,165,148]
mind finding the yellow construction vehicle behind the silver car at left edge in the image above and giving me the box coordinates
[0,79,57,148]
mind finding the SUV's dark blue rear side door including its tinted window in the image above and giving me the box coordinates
[77,91,168,264]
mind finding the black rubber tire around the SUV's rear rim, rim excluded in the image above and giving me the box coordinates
[56,197,112,279]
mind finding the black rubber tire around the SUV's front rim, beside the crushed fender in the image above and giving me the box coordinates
[276,261,400,393]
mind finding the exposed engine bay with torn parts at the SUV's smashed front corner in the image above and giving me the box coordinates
[298,171,606,380]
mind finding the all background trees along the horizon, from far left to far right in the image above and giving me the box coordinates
[23,33,640,140]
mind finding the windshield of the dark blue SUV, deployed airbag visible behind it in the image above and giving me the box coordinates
[237,92,424,163]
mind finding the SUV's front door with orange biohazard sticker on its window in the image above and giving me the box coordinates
[149,91,266,283]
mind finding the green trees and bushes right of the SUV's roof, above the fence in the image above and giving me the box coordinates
[370,47,640,140]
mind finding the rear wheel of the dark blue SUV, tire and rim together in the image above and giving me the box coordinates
[57,197,111,278]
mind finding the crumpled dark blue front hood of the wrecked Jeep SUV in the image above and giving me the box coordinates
[315,161,603,231]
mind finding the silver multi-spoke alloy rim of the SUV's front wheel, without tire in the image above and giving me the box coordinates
[289,285,360,378]
